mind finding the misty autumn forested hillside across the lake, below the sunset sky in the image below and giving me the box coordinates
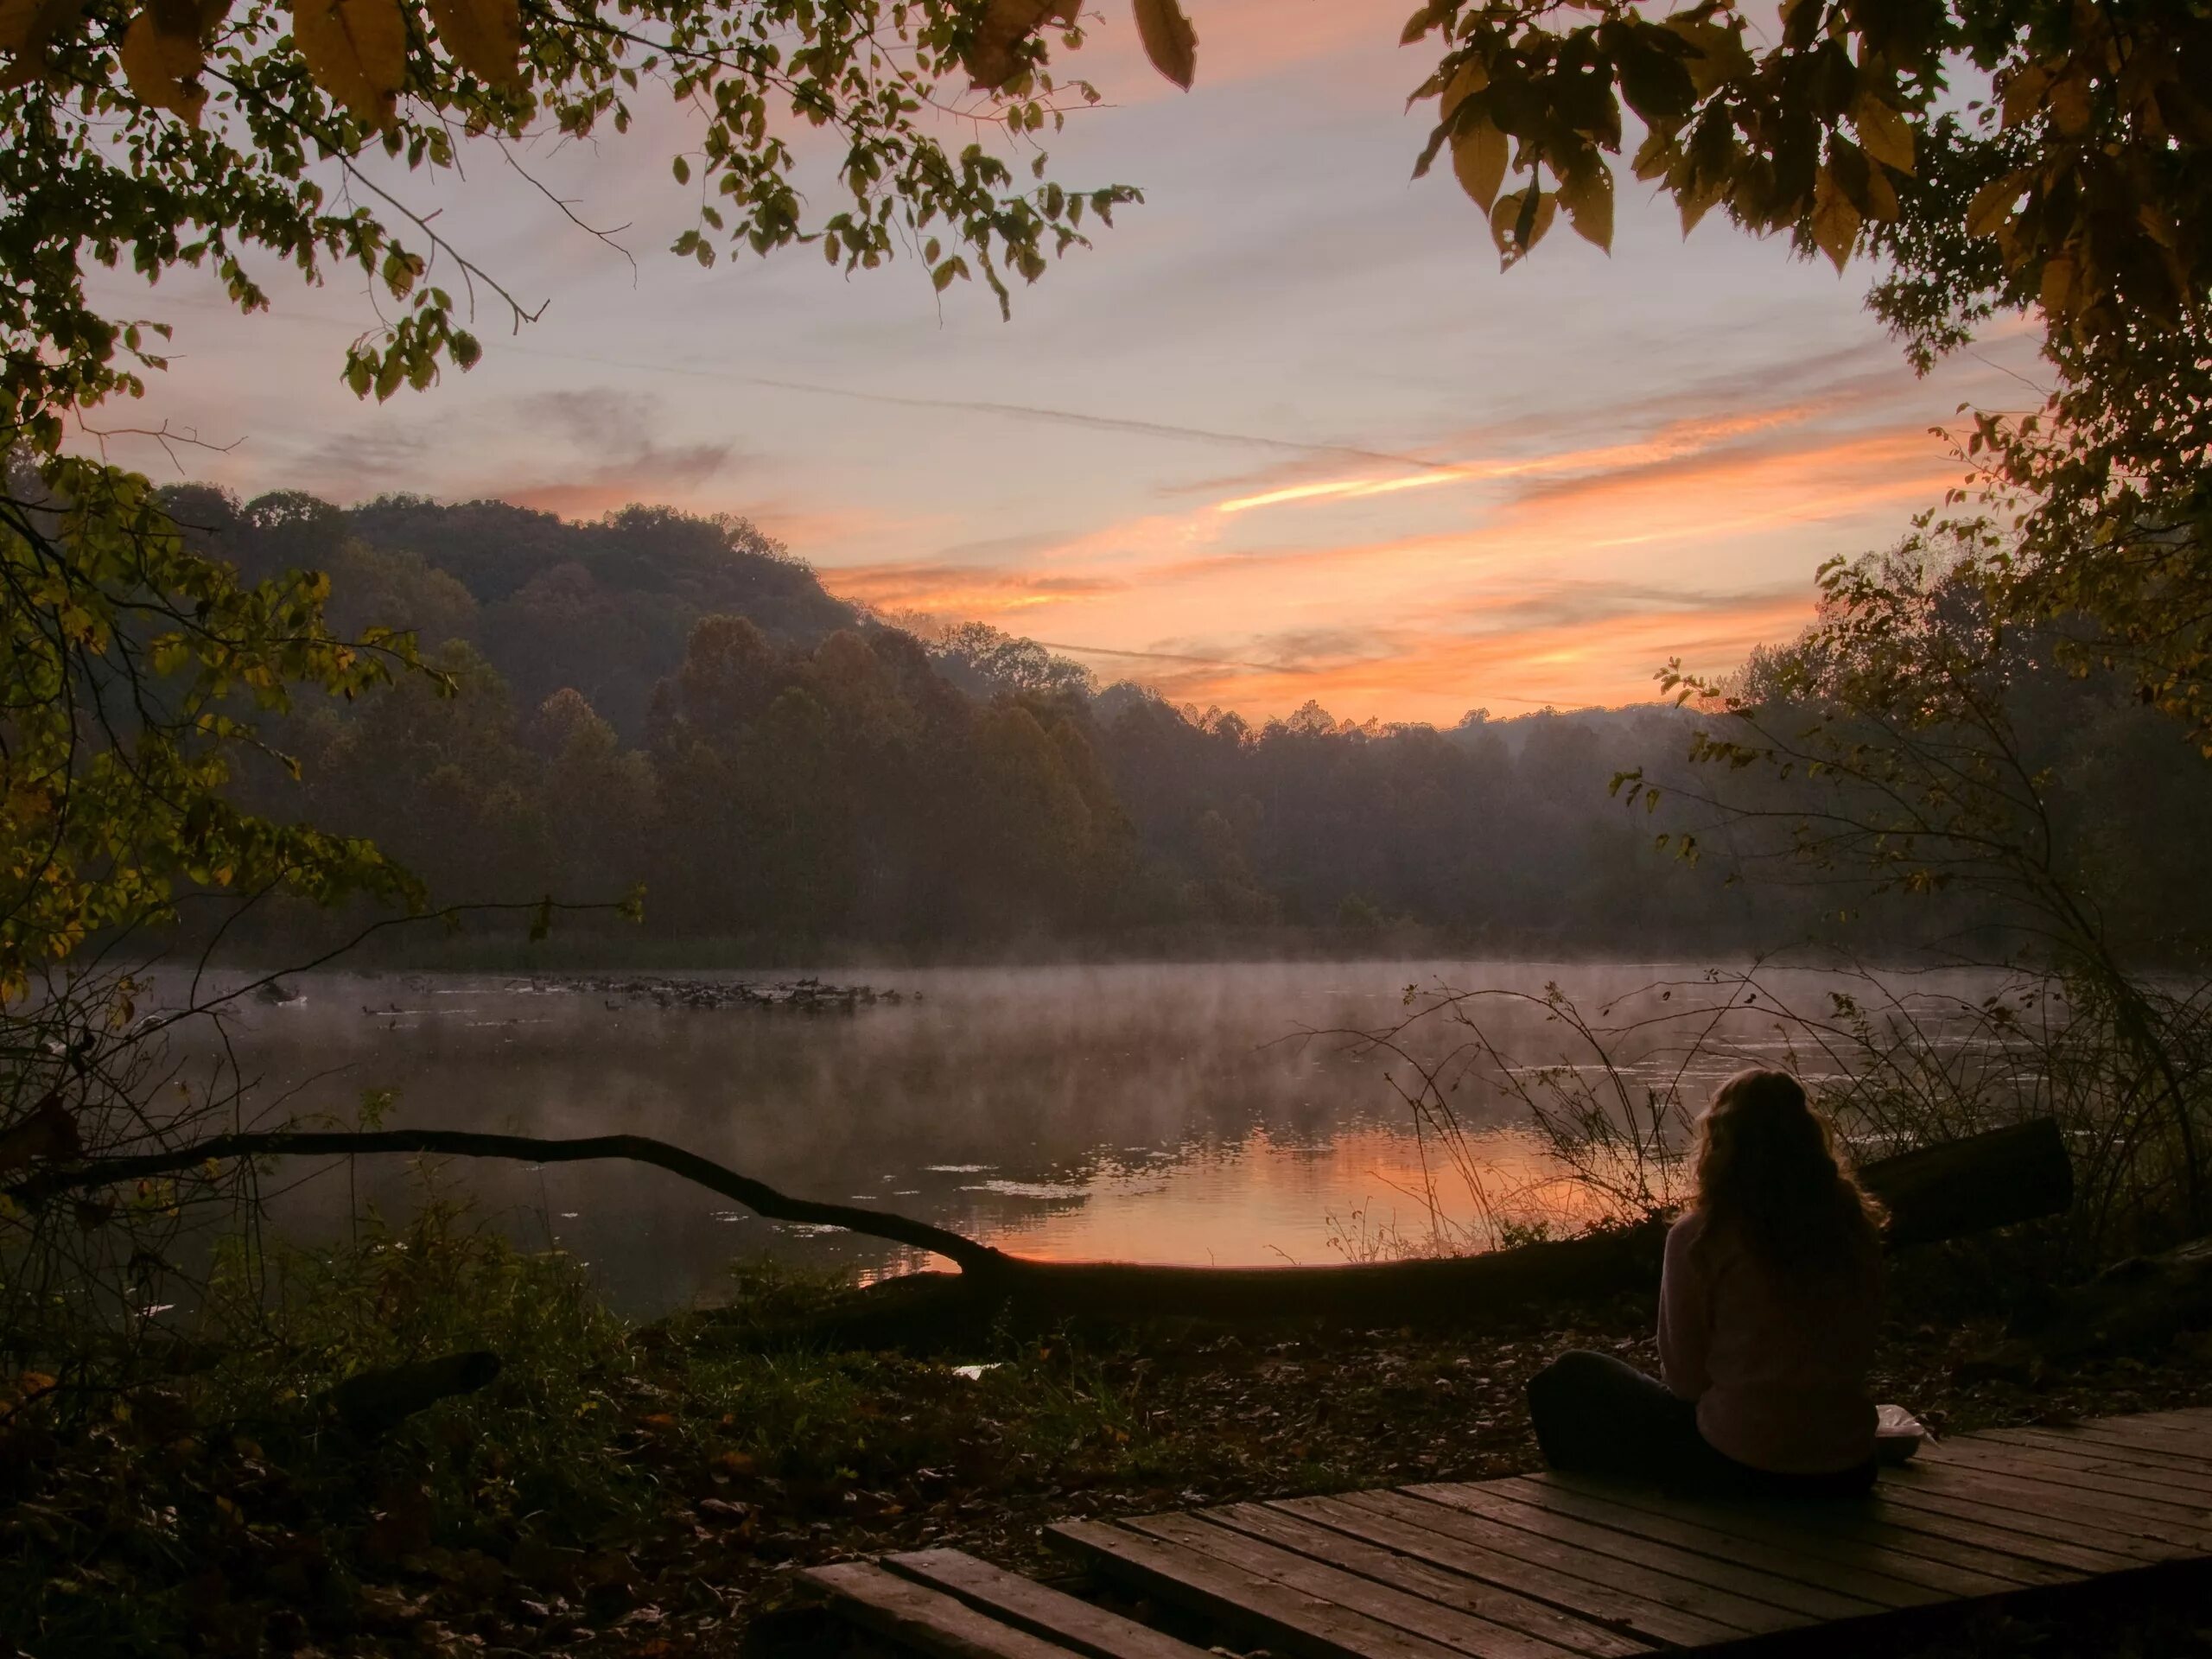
[168,486,2212,953]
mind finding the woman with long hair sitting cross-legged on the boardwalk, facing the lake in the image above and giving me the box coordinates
[1529,1071,1883,1496]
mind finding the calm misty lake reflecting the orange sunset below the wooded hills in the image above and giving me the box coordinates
[194,963,2008,1312]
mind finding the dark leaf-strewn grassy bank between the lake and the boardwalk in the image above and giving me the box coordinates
[0,1232,2212,1659]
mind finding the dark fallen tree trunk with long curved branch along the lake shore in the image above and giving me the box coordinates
[7,1119,2073,1334]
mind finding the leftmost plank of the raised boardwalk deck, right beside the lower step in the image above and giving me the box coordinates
[1044,1522,1465,1659]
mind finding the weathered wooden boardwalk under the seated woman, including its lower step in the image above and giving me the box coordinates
[810,1411,2212,1659]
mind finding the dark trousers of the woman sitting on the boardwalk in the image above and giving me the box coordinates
[1529,1350,1873,1497]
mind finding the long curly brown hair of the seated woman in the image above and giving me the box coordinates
[1697,1066,1883,1276]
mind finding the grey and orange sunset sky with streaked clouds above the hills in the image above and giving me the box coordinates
[98,0,2037,723]
